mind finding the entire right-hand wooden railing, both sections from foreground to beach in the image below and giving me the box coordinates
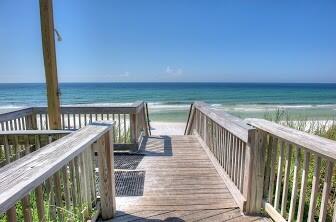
[185,102,336,222]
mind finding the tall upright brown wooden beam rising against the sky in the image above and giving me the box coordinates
[40,0,61,129]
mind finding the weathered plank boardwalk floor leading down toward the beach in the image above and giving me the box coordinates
[110,136,265,222]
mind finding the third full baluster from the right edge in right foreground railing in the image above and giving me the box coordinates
[296,150,310,222]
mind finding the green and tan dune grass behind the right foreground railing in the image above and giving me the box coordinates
[264,110,336,221]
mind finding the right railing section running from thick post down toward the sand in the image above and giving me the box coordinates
[185,102,261,213]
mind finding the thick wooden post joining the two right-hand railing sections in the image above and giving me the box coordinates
[243,129,266,214]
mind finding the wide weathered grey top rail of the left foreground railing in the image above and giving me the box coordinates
[0,122,112,212]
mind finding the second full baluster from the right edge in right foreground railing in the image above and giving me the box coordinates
[307,155,321,221]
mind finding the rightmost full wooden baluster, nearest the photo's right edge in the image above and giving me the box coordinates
[319,160,334,222]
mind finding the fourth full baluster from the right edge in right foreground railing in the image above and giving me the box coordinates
[288,147,301,221]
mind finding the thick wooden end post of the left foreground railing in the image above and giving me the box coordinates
[95,130,116,220]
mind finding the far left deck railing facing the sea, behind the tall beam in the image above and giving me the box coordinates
[0,101,150,150]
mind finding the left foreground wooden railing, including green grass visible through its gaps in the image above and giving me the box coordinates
[0,121,115,221]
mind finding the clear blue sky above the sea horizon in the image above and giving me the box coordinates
[0,0,336,82]
